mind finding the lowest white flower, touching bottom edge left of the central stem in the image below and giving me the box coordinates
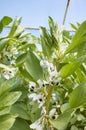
[30,118,44,130]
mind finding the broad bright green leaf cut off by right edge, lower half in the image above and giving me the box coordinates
[69,82,86,108]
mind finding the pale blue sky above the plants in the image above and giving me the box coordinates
[0,0,86,35]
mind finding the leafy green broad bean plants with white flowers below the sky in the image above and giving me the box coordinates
[0,16,86,130]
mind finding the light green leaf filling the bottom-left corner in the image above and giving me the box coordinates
[0,115,15,130]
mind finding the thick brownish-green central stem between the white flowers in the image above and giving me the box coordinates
[46,86,54,115]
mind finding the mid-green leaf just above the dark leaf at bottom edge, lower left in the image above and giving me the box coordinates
[11,103,30,120]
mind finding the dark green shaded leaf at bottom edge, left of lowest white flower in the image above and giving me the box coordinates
[10,118,30,130]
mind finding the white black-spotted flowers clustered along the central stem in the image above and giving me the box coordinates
[28,60,61,130]
